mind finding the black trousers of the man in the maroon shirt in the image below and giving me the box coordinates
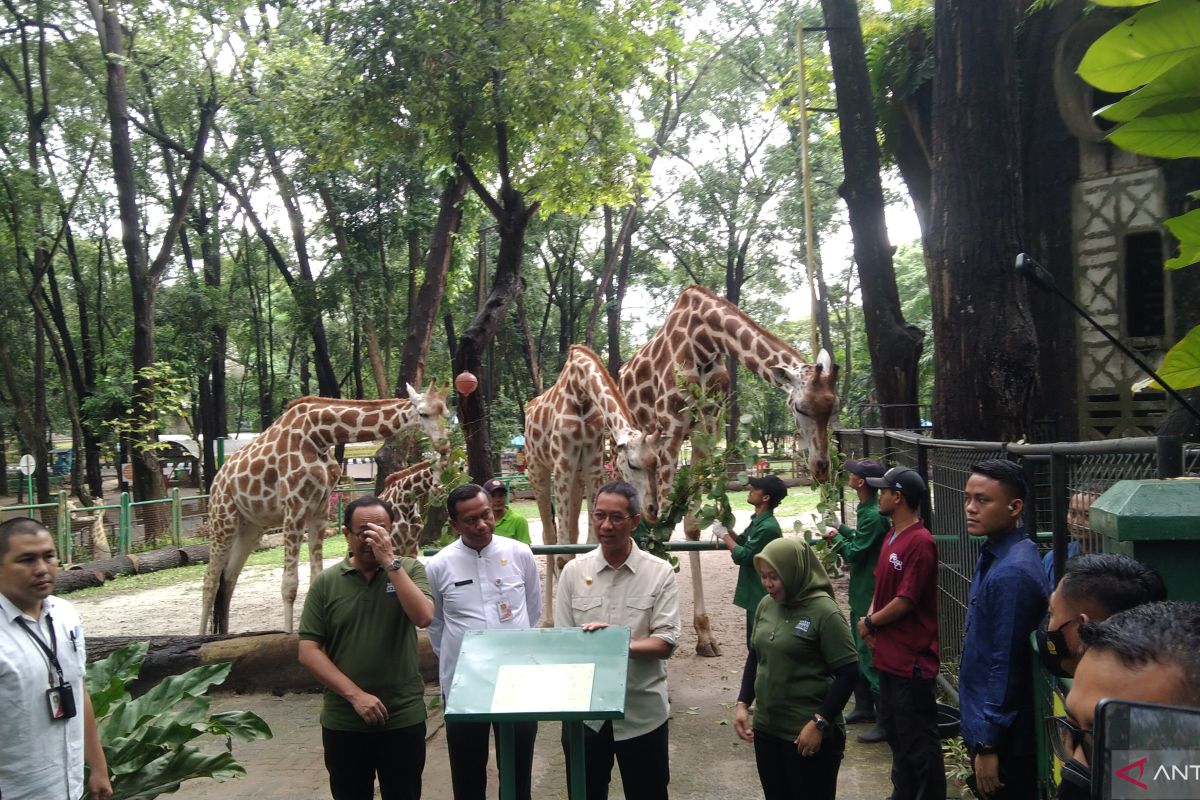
[878,672,946,800]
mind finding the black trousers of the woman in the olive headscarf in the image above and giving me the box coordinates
[754,726,846,800]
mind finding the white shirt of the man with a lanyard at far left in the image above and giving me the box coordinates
[0,595,86,800]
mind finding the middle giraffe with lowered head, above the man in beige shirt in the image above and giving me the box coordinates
[526,344,662,626]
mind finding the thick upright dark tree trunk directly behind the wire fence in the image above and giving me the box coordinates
[926,0,1038,440]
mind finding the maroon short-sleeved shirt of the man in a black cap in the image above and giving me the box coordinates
[871,522,941,678]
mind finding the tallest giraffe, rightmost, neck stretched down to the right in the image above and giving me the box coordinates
[618,285,838,656]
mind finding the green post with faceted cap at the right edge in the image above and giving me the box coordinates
[1088,477,1200,602]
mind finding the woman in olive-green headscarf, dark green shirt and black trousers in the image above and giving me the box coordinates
[733,539,858,800]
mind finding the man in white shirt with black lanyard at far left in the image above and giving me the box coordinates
[0,517,113,800]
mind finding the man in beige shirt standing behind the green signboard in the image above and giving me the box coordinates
[554,481,679,800]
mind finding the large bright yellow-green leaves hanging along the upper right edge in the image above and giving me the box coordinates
[1079,0,1200,389]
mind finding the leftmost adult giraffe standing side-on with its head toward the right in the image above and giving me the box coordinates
[200,383,450,634]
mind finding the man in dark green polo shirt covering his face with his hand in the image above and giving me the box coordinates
[300,497,433,800]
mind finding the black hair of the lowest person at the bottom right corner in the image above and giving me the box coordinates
[1079,602,1200,706]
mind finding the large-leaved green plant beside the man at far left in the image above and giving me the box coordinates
[86,642,271,800]
